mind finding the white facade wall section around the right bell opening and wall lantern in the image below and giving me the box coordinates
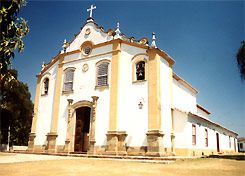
[118,44,148,146]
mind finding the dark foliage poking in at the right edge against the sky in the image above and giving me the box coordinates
[236,41,245,80]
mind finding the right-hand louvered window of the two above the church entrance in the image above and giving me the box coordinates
[97,63,109,86]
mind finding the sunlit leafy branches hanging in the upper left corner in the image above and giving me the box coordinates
[0,0,29,82]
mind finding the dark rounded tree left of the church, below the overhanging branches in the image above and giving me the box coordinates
[0,70,33,145]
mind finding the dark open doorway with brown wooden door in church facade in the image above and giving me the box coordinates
[74,107,91,153]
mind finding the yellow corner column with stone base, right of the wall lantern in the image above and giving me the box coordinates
[146,48,163,156]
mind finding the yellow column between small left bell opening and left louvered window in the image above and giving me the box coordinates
[47,56,64,153]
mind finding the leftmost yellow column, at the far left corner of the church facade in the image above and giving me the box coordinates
[27,75,41,152]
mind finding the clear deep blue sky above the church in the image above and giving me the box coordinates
[13,1,245,136]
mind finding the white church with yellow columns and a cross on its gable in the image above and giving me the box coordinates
[27,5,238,156]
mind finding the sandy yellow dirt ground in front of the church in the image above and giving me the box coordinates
[0,155,245,176]
